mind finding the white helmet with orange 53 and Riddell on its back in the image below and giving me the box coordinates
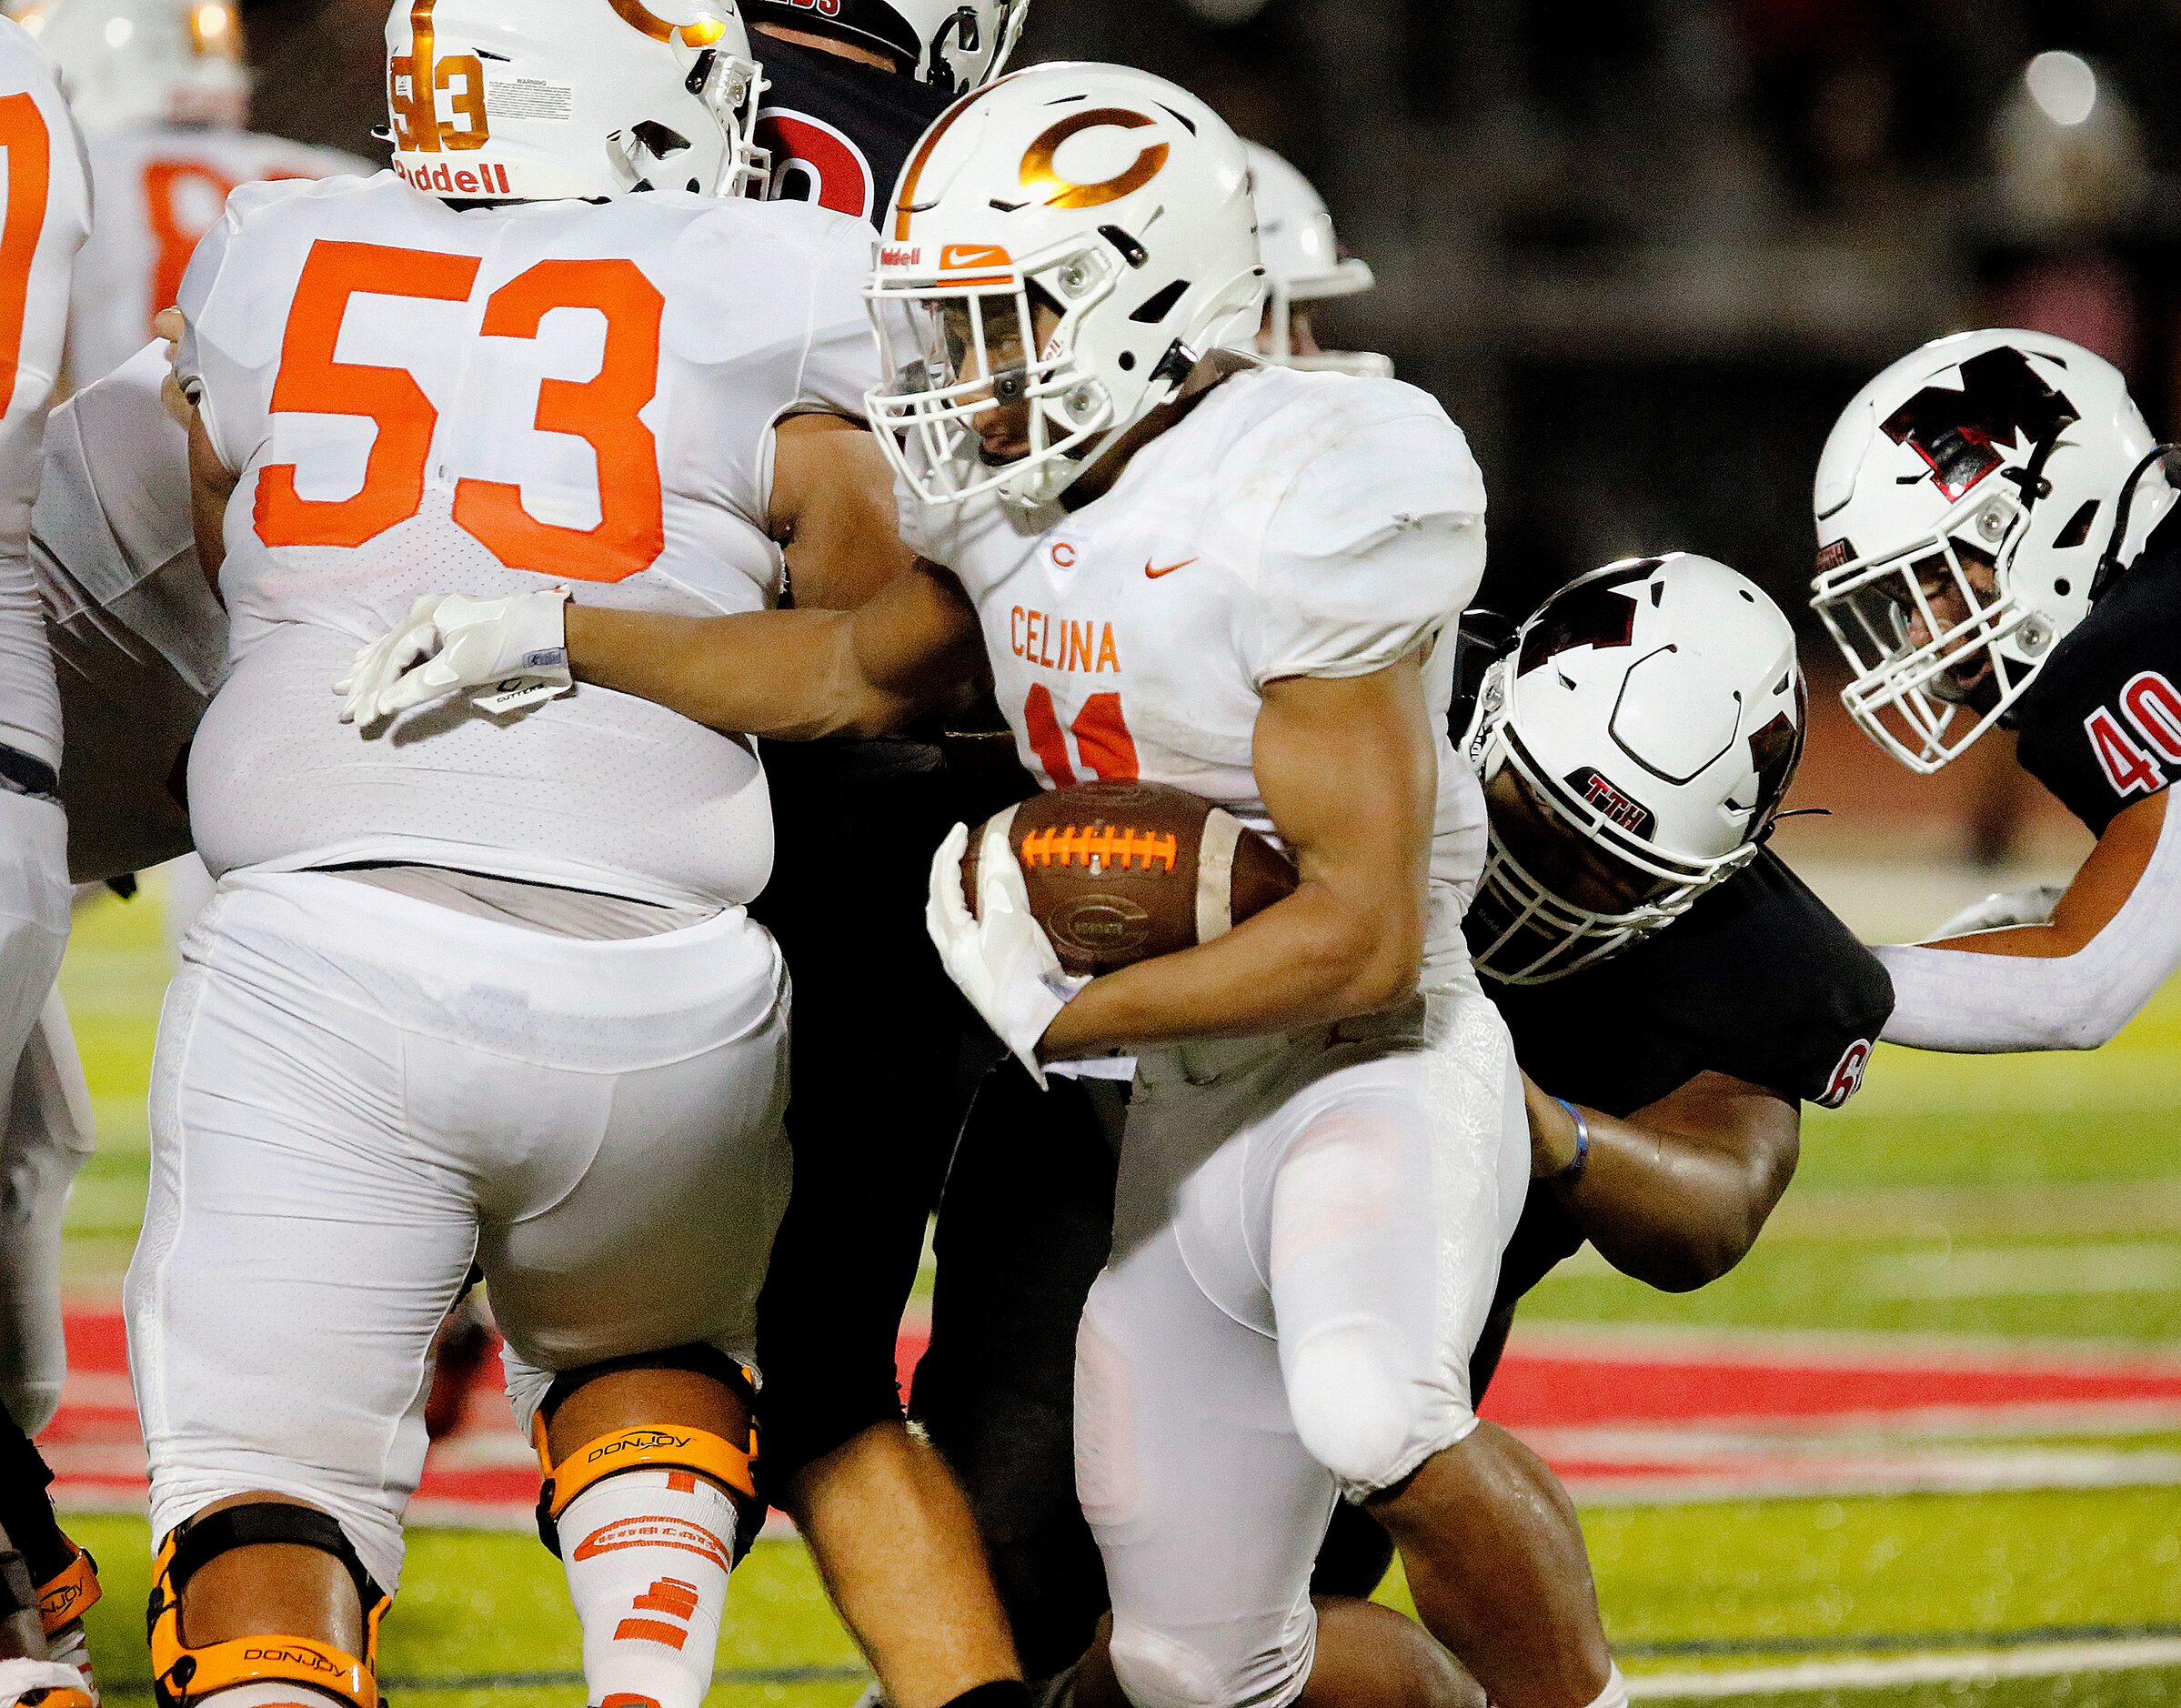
[386,0,766,201]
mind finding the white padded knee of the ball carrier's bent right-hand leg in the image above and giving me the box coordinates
[1287,1321,1470,1494]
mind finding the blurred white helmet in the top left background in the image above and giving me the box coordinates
[6,0,251,133]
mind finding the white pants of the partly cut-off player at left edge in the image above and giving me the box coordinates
[0,789,78,1435]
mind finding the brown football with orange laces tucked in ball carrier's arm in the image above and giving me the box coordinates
[962,783,1298,973]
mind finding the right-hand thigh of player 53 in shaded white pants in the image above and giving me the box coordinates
[477,995,791,1412]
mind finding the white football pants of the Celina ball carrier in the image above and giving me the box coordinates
[1075,969,1529,1708]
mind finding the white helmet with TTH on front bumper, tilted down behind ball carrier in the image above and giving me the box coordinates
[1463,552,1808,984]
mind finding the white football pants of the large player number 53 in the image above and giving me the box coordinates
[126,872,789,1592]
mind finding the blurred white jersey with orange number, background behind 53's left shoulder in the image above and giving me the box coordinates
[67,125,379,387]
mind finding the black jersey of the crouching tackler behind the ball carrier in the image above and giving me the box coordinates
[1485,849,1893,1311]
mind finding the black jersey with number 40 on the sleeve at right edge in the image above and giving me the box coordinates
[2006,508,2181,836]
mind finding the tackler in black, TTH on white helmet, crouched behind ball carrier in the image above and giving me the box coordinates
[919,554,1891,1693]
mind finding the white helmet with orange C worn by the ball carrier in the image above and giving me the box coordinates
[868,64,1261,508]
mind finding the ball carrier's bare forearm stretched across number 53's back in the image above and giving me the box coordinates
[567,602,916,741]
